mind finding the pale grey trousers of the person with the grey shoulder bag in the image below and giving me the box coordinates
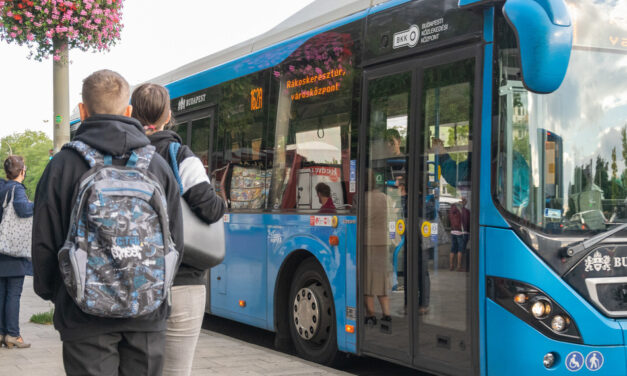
[163,285,206,376]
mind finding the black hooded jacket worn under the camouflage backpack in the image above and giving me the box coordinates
[32,115,183,341]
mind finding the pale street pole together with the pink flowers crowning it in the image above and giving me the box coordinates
[0,0,123,151]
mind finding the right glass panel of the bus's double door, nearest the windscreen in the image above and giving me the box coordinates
[416,59,475,367]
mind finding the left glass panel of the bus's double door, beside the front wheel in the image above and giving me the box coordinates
[362,72,412,359]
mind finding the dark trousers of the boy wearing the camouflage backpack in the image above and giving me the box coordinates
[63,332,165,376]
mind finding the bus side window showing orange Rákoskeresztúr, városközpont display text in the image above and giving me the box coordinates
[268,28,358,211]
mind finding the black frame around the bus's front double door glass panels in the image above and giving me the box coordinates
[357,43,491,375]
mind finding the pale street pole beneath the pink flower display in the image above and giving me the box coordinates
[52,39,70,153]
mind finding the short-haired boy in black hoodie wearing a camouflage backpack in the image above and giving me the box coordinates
[32,70,183,375]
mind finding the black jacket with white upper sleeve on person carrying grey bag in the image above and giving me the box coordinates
[148,130,226,286]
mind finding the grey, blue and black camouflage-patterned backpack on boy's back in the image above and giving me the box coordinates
[58,141,179,318]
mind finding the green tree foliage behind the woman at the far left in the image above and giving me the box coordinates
[0,130,52,200]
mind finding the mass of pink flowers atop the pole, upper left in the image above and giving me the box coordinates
[0,0,123,61]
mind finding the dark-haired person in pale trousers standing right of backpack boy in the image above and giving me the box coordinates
[131,84,226,375]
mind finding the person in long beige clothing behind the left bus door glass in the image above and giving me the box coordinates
[364,170,392,326]
